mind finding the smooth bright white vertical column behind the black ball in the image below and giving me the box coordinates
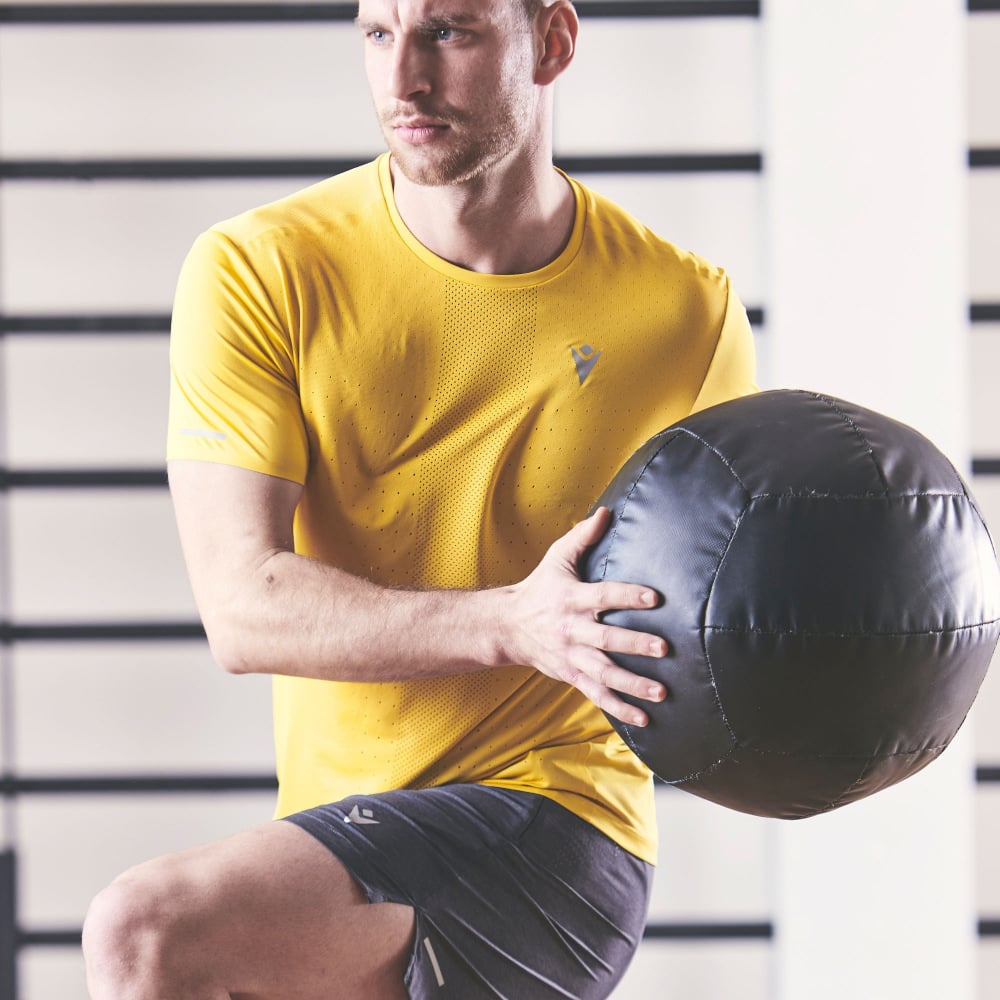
[762,0,976,1000]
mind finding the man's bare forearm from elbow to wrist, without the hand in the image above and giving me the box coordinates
[200,551,506,681]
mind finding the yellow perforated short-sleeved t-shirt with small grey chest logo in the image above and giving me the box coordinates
[168,156,754,861]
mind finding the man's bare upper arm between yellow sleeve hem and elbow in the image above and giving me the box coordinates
[167,460,302,616]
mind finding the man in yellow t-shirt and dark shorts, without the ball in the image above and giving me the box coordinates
[84,0,753,1000]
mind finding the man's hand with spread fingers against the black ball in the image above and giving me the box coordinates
[499,507,667,726]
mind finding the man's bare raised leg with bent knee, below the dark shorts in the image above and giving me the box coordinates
[83,823,414,1000]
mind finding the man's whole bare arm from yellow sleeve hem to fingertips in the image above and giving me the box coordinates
[169,462,666,725]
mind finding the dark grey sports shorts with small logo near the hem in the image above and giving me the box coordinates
[287,785,653,1000]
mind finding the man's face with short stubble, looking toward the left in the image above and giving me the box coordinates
[358,0,539,185]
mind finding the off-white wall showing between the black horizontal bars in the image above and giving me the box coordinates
[0,5,1000,1000]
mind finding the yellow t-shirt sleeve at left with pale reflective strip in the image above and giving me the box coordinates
[167,230,308,484]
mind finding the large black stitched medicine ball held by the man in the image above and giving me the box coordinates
[581,390,1000,818]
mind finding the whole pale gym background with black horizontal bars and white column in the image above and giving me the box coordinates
[0,0,1000,1000]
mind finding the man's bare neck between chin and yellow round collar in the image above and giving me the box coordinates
[390,157,576,274]
